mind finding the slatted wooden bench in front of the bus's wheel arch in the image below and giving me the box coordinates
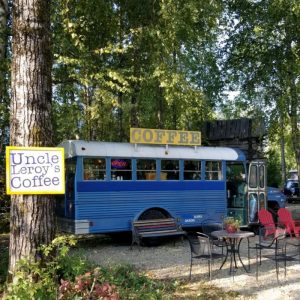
[131,218,185,249]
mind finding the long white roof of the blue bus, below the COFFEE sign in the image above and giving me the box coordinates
[58,140,246,161]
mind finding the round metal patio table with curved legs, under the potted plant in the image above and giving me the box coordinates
[211,230,255,273]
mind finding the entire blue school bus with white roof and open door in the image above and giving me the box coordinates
[56,140,266,234]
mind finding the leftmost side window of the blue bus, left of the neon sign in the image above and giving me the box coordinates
[83,158,106,180]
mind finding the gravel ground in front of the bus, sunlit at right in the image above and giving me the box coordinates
[82,237,300,300]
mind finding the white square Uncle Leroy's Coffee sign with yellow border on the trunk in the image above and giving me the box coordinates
[6,147,65,195]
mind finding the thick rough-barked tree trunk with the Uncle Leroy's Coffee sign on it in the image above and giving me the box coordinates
[9,0,54,275]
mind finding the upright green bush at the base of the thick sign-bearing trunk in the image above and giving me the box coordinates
[5,236,88,300]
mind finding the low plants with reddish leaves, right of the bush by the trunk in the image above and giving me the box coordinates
[59,265,178,300]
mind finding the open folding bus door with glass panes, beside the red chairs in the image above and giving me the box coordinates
[248,161,267,224]
